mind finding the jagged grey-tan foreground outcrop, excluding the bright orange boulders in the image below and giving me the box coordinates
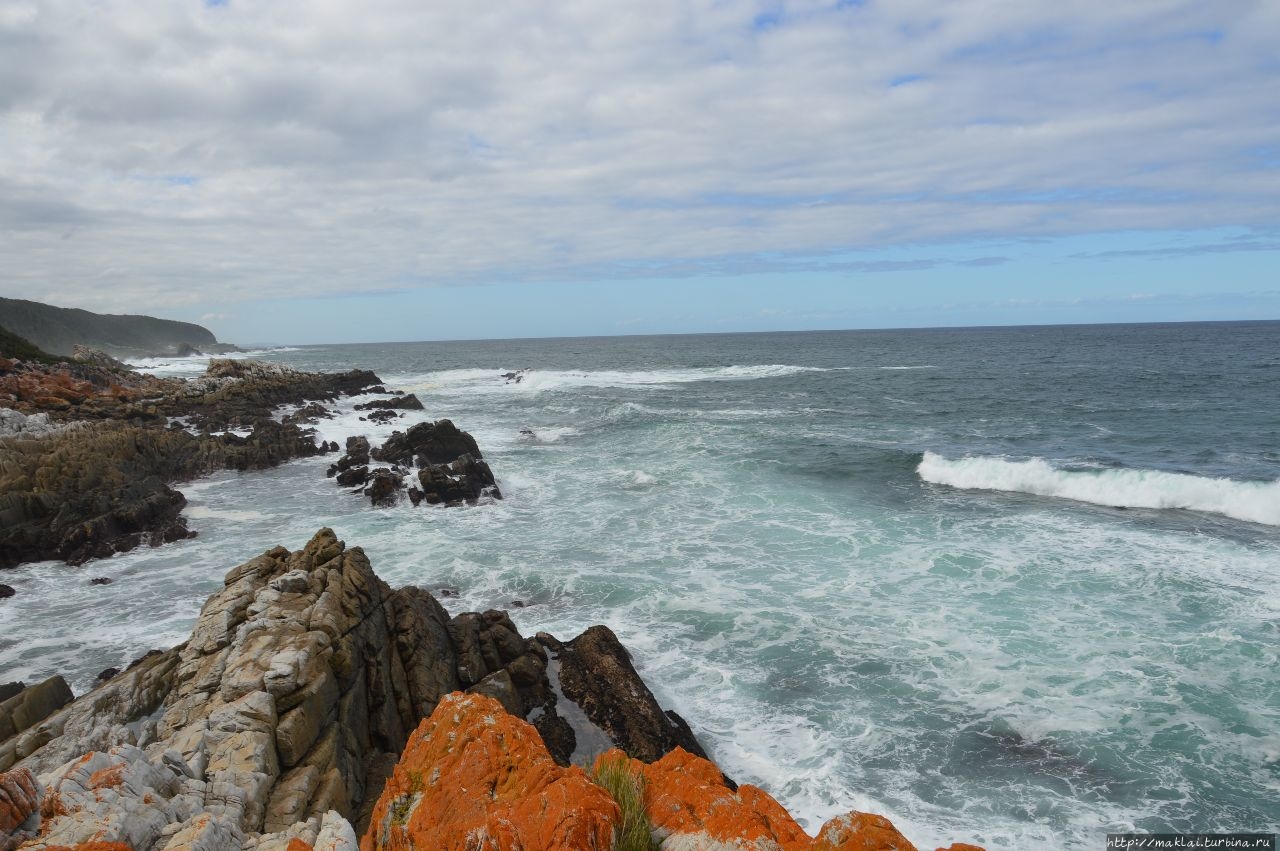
[0,530,747,851]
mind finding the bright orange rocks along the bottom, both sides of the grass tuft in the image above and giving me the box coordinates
[360,695,982,851]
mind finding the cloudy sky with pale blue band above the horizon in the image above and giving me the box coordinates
[0,0,1280,344]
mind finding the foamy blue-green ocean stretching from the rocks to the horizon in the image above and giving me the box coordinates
[0,322,1280,851]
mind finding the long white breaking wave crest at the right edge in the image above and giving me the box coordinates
[918,452,1280,526]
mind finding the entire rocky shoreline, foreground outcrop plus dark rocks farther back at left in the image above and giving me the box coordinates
[0,352,977,851]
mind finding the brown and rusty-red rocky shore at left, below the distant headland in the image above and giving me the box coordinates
[0,358,379,567]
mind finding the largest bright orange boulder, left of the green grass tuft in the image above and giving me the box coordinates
[360,694,621,851]
